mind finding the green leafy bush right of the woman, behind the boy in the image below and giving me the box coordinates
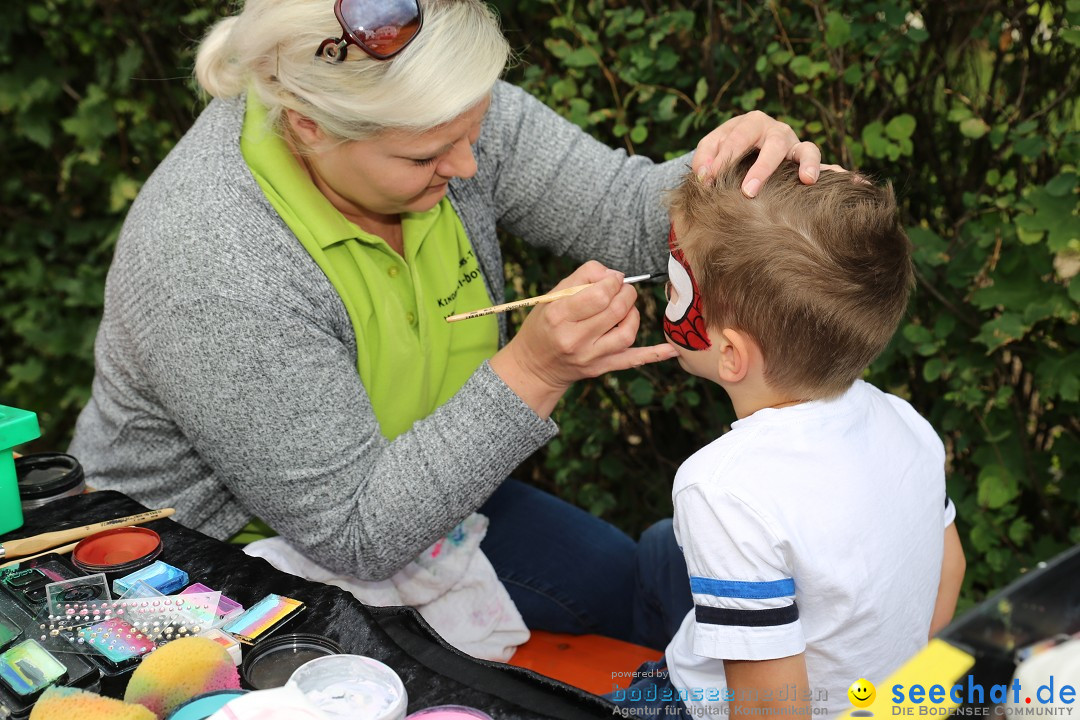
[500,0,1080,601]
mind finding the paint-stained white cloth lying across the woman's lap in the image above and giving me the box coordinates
[244,513,529,662]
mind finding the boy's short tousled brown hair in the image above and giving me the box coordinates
[667,151,914,399]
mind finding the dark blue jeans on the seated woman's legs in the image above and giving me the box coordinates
[477,479,692,650]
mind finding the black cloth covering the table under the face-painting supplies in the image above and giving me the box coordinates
[0,491,615,720]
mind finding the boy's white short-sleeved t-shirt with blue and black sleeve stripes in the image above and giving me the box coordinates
[666,381,956,717]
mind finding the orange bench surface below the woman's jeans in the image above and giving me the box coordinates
[510,630,663,695]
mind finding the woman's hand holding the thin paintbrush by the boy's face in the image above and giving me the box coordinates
[491,261,677,418]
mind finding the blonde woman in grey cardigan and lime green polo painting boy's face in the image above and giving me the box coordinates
[70,0,820,648]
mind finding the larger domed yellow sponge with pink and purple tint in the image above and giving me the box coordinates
[123,637,240,720]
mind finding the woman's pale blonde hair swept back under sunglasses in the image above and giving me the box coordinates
[195,0,510,140]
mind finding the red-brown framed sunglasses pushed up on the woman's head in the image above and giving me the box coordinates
[315,0,423,63]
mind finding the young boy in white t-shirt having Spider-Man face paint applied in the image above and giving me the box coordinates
[615,155,963,717]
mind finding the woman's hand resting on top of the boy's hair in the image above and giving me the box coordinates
[690,110,821,198]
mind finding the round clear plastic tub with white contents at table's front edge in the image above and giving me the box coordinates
[288,655,408,720]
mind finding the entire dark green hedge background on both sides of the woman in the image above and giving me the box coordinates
[0,0,1080,602]
